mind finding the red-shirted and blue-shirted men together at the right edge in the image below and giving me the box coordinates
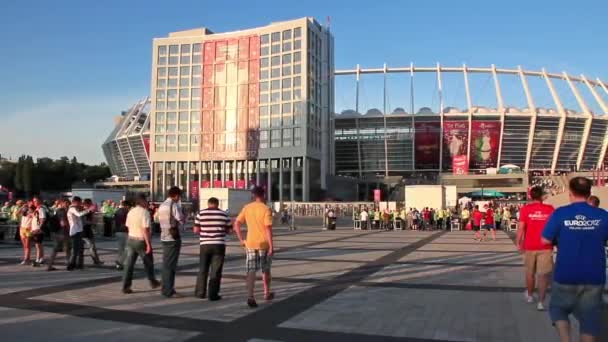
[516,177,608,342]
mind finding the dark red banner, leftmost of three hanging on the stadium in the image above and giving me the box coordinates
[414,122,441,169]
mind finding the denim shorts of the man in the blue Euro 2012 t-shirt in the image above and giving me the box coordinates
[549,282,603,336]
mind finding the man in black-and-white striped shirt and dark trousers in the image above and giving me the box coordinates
[194,197,232,301]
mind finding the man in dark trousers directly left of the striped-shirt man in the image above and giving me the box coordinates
[158,186,186,298]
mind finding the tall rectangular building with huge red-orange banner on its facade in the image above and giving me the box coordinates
[150,18,333,201]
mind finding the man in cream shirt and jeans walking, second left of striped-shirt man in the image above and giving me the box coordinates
[122,195,160,294]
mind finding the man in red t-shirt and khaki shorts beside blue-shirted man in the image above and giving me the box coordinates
[517,186,555,310]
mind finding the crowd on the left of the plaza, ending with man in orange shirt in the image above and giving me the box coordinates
[2,187,274,308]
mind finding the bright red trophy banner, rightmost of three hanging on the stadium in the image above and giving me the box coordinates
[470,121,500,169]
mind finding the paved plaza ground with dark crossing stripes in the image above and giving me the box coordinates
[0,223,608,342]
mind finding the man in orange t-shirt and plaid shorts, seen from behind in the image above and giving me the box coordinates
[234,187,274,308]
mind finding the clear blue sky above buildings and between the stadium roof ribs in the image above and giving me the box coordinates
[0,0,608,162]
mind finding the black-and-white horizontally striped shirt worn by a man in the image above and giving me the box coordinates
[194,208,232,245]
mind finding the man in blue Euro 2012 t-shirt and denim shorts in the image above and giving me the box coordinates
[542,177,608,341]
